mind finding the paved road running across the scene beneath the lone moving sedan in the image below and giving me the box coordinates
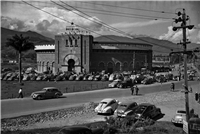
[0,81,199,119]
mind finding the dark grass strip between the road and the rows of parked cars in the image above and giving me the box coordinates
[0,81,109,99]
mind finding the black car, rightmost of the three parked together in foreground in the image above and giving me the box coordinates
[128,103,162,119]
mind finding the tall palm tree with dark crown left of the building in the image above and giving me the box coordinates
[6,34,35,84]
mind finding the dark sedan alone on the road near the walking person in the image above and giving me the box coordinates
[31,87,63,100]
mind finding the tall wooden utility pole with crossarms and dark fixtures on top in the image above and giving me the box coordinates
[173,9,194,133]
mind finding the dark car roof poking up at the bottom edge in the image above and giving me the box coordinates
[58,126,104,134]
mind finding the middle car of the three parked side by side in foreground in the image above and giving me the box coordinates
[115,102,138,117]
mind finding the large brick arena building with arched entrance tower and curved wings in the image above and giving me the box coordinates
[35,31,152,73]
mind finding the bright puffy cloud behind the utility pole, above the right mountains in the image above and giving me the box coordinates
[159,26,200,42]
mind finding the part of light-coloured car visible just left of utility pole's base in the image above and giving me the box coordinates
[171,110,186,125]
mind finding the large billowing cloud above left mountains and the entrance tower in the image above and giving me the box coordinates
[0,7,104,38]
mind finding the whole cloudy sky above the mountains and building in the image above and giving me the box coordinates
[0,0,200,44]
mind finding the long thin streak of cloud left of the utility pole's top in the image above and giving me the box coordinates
[112,20,168,28]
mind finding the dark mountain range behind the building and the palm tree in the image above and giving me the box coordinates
[0,27,200,58]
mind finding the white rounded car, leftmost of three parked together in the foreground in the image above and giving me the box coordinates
[95,98,119,114]
